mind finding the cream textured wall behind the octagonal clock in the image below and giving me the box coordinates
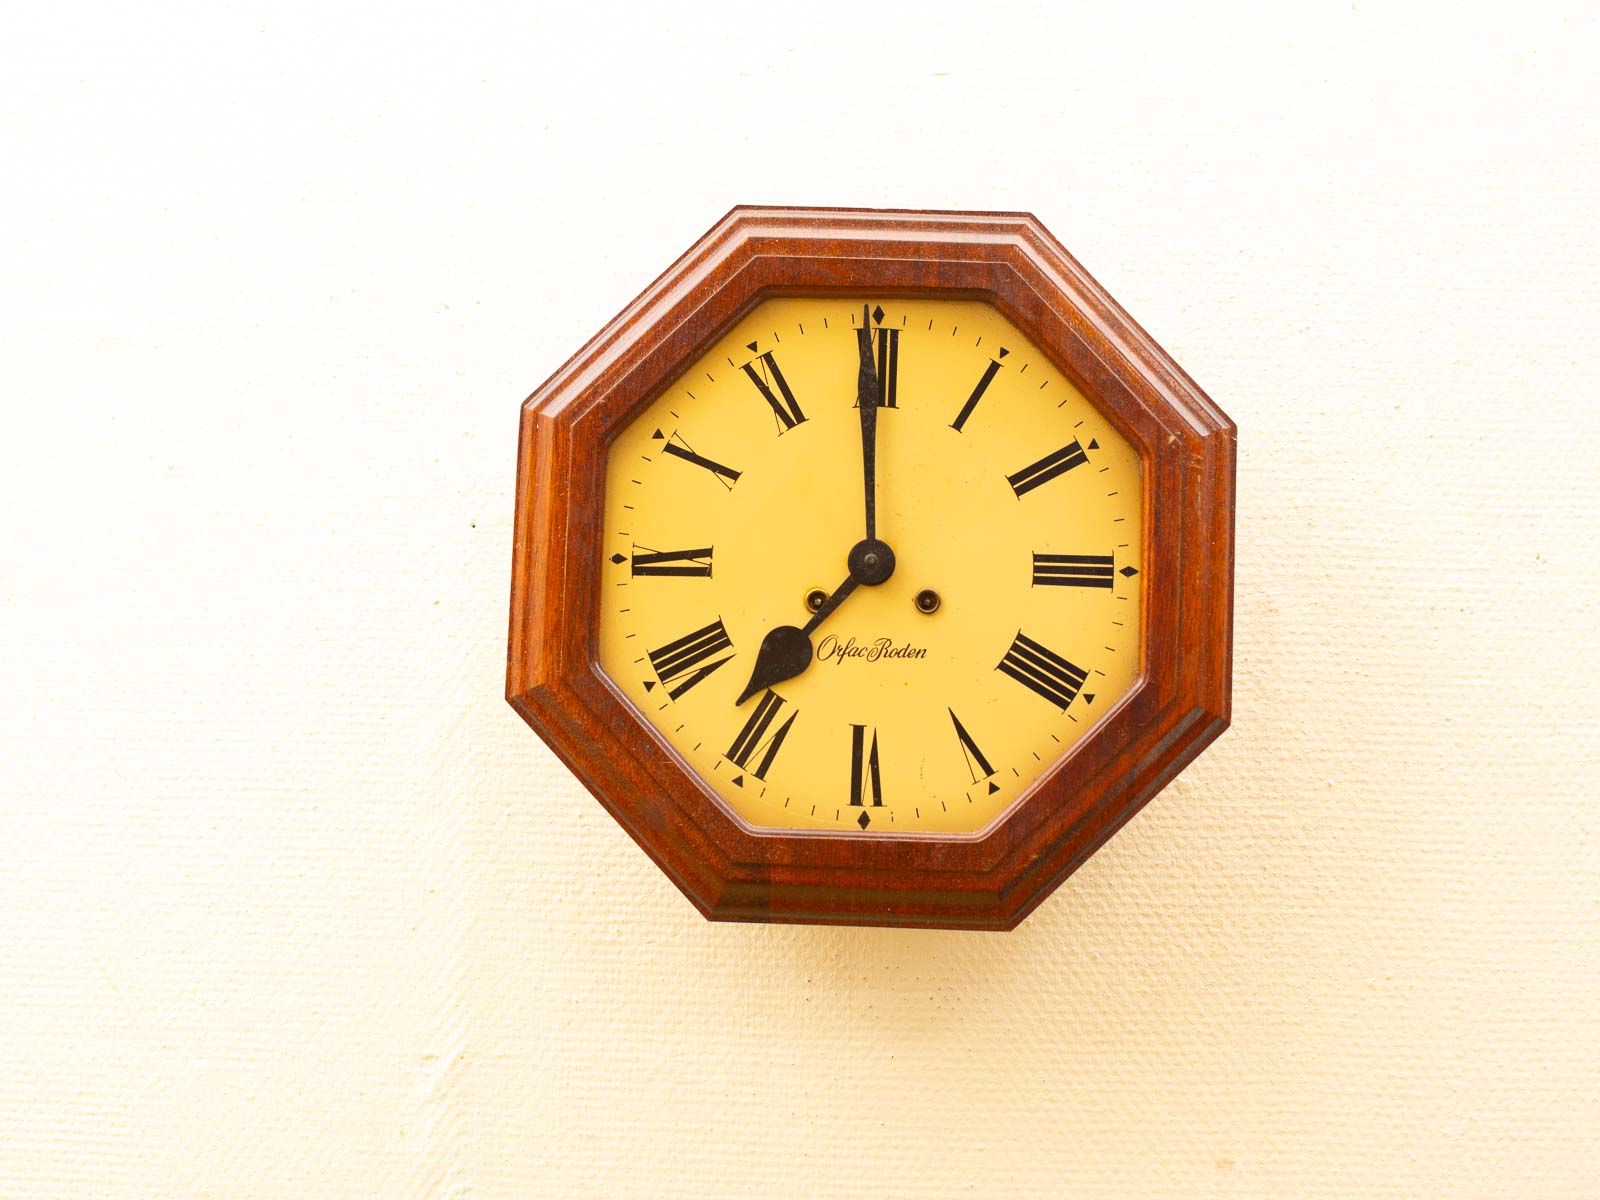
[0,0,1600,1200]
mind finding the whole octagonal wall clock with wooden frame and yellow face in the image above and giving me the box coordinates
[507,208,1234,930]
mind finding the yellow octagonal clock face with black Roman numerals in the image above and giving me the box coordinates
[600,298,1144,837]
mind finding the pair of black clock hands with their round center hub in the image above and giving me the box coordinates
[734,304,894,706]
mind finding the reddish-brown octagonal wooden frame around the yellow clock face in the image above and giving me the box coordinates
[507,208,1234,930]
